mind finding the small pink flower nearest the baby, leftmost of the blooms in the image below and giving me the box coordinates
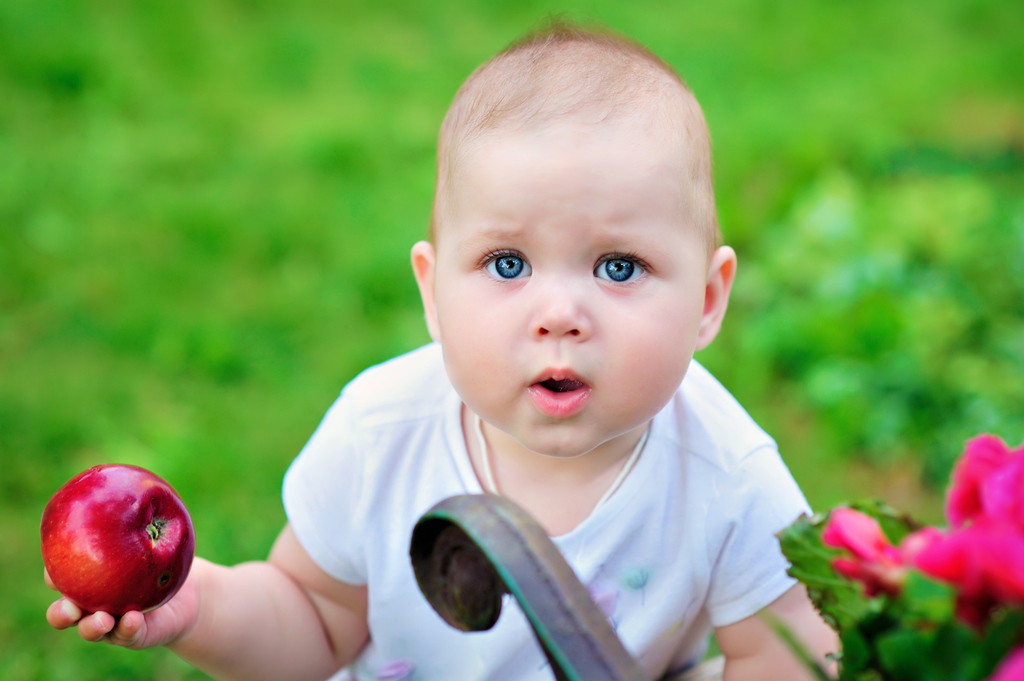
[821,508,906,596]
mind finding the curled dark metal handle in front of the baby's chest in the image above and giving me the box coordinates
[409,495,646,681]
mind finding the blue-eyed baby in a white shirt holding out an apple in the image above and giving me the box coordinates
[47,19,836,681]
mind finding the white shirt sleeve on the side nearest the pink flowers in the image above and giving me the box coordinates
[708,445,809,627]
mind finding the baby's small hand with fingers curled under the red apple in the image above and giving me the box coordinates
[43,570,199,650]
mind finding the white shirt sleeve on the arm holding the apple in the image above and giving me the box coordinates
[283,391,367,585]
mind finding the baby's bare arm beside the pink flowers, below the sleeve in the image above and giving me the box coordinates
[715,585,839,681]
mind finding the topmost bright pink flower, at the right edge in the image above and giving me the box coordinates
[946,435,1024,529]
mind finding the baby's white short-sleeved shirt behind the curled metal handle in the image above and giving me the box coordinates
[284,344,808,681]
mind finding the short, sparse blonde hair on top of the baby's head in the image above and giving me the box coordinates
[430,18,721,257]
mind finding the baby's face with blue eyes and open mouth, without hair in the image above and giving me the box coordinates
[414,125,713,456]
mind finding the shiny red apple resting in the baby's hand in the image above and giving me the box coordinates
[40,464,196,616]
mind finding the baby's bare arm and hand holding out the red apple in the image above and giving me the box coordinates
[46,525,368,680]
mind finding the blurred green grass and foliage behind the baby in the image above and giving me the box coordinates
[0,0,1024,681]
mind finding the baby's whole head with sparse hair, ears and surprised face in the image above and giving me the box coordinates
[412,25,735,457]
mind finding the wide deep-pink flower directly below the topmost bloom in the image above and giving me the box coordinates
[911,517,1024,628]
